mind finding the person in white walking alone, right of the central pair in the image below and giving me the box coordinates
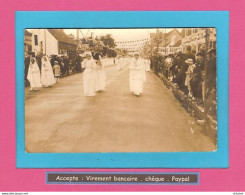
[129,53,145,96]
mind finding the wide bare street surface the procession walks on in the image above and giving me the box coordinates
[25,66,216,152]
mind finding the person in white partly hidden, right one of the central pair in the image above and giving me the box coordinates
[95,54,106,92]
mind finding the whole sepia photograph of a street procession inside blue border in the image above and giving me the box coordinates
[23,27,218,153]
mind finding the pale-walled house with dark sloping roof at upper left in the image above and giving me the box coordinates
[31,29,77,55]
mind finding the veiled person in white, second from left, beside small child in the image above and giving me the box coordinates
[41,55,56,87]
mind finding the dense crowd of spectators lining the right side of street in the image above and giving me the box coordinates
[151,46,216,119]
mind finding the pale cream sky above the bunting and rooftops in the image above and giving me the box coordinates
[64,28,179,41]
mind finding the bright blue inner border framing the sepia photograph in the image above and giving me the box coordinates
[15,11,229,168]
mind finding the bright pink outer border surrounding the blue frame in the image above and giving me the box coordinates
[0,0,245,191]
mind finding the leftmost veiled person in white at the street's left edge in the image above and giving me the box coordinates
[27,57,42,90]
